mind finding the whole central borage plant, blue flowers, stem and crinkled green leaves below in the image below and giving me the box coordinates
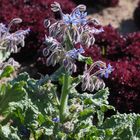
[0,2,140,140]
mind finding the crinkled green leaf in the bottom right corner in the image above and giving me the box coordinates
[101,113,140,140]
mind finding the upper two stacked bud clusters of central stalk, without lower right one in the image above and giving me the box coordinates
[43,2,103,73]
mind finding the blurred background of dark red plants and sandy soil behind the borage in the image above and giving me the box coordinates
[0,0,140,113]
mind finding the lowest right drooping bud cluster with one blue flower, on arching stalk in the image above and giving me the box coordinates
[82,61,113,92]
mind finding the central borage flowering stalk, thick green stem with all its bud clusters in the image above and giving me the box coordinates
[43,2,113,123]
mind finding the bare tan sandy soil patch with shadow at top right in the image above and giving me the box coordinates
[91,0,139,34]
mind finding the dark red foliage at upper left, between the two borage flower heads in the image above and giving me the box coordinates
[0,0,75,61]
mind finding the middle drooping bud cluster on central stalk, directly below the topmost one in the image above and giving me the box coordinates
[43,37,84,73]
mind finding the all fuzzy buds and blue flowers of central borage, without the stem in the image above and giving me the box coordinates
[43,2,113,92]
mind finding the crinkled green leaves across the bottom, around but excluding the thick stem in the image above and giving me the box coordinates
[0,73,140,140]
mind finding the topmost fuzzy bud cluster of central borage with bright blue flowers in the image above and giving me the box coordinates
[44,2,103,47]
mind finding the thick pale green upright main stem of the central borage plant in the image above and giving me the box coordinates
[60,73,70,122]
